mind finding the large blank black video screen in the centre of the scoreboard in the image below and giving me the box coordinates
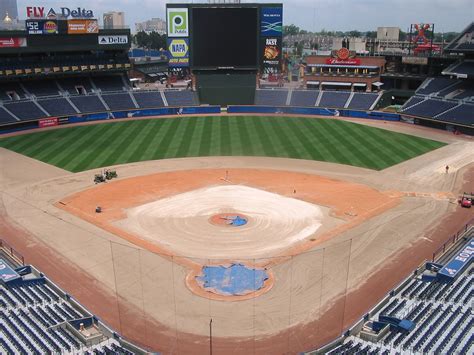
[191,7,258,68]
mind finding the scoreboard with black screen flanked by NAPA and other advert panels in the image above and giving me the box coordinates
[166,4,283,73]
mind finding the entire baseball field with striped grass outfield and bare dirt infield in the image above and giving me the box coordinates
[0,114,474,355]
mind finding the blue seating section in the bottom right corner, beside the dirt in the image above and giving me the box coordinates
[327,239,474,354]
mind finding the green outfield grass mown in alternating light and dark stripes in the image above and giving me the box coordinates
[0,116,445,172]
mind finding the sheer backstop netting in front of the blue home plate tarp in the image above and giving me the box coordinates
[110,240,352,354]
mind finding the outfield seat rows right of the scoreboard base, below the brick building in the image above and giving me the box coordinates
[255,89,379,110]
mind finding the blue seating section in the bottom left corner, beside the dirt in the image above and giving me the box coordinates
[0,257,144,355]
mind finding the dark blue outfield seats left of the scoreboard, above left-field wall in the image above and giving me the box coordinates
[0,90,199,125]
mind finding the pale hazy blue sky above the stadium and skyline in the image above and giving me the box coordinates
[16,0,474,32]
